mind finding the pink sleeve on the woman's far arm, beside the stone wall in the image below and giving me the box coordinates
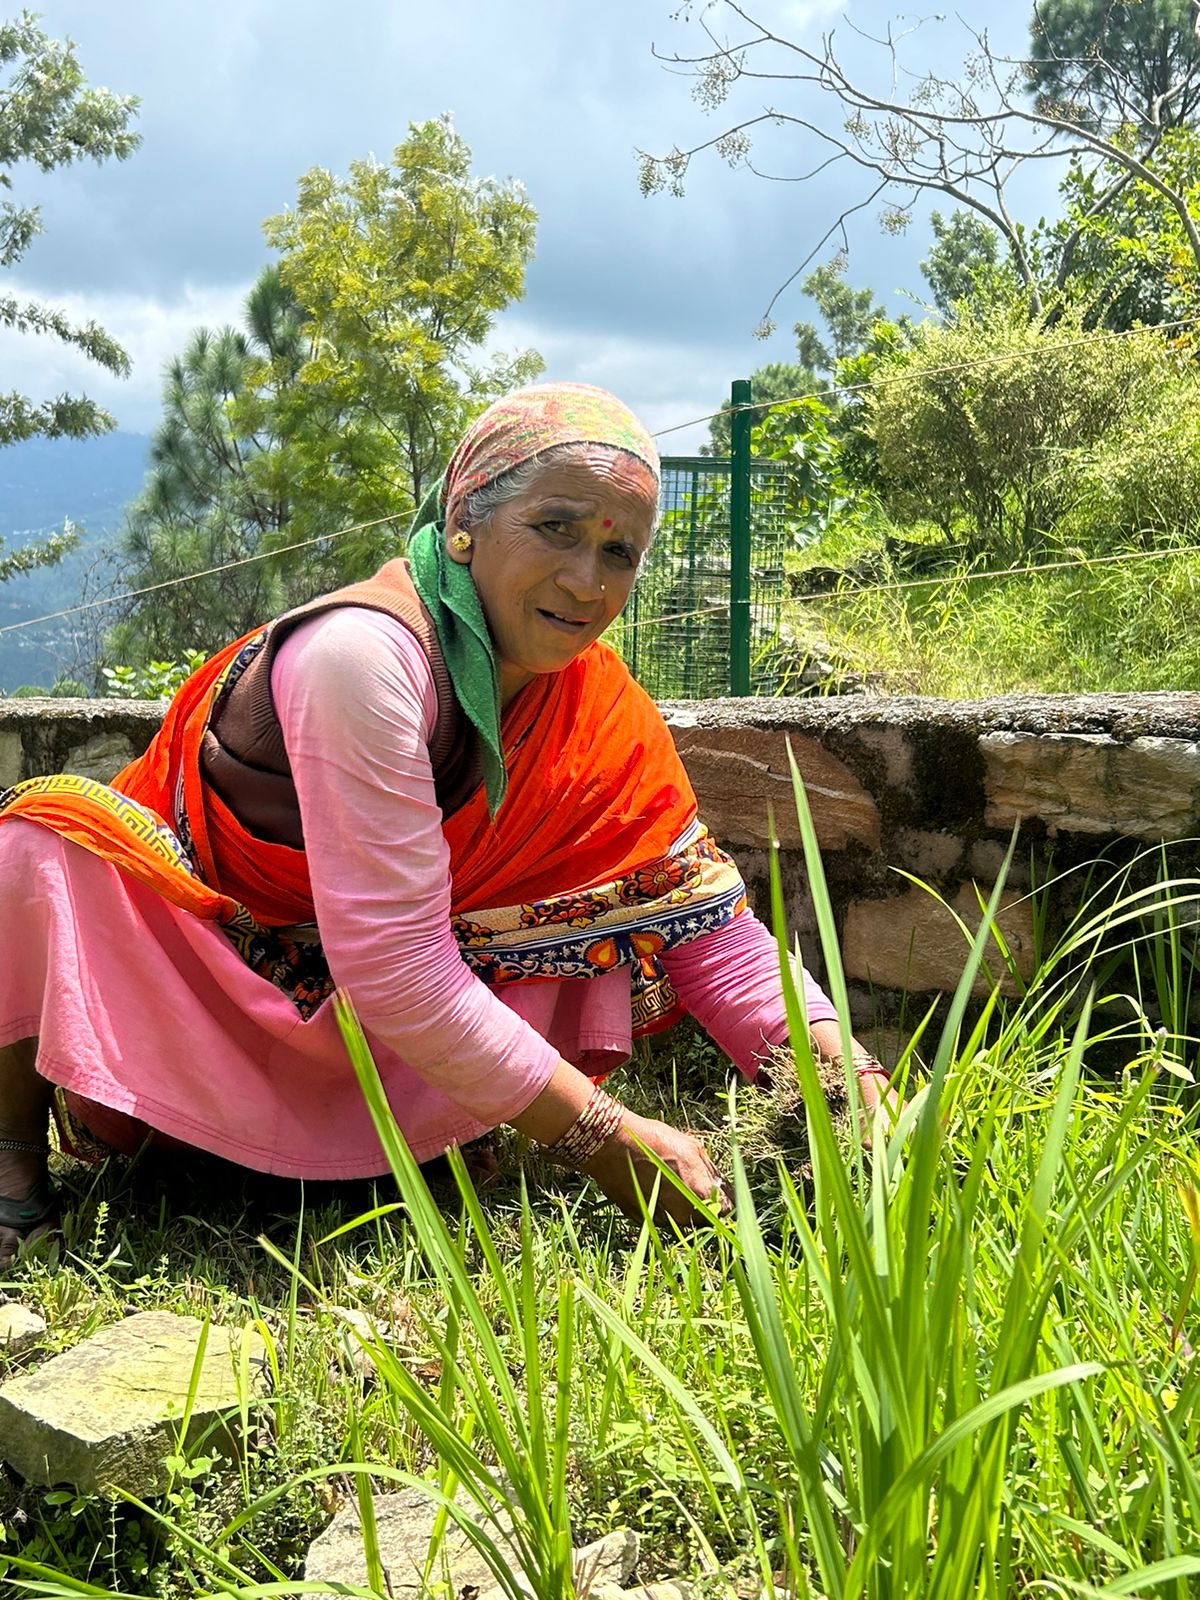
[661,910,837,1078]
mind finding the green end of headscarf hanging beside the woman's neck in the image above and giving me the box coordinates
[408,483,509,816]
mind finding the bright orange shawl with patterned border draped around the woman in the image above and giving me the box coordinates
[0,634,746,1034]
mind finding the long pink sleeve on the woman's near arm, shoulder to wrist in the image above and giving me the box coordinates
[270,606,558,1126]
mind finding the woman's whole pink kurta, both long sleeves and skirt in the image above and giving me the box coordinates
[0,608,834,1178]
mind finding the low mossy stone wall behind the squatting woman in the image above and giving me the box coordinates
[0,694,1200,1024]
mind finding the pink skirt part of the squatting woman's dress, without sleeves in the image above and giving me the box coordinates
[0,818,630,1179]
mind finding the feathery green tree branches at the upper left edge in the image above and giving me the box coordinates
[0,11,139,445]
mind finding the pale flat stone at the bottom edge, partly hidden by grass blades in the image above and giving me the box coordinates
[304,1490,638,1600]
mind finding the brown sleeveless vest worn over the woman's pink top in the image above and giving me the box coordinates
[200,560,480,850]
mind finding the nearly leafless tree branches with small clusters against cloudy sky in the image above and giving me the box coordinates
[638,0,1200,328]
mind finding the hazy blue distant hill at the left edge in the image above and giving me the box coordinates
[0,434,150,691]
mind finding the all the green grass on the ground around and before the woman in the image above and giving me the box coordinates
[0,806,1200,1600]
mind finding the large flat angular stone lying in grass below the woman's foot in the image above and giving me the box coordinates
[0,1310,266,1494]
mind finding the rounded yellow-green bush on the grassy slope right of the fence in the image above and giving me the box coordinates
[869,296,1174,558]
